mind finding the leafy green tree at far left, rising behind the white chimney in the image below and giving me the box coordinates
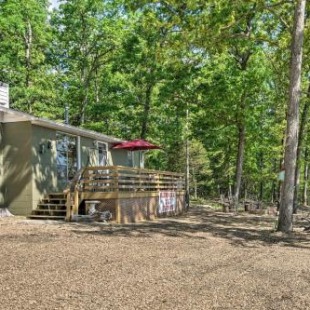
[0,0,55,115]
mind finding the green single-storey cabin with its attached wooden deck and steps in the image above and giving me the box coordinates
[0,83,185,223]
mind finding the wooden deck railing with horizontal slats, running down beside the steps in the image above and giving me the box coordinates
[67,166,185,219]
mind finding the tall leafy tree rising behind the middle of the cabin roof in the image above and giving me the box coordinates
[52,0,121,125]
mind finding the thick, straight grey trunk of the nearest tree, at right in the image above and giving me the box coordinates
[277,0,306,232]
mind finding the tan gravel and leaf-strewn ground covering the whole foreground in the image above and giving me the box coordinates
[0,206,310,310]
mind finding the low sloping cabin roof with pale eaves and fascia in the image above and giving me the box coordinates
[0,106,123,143]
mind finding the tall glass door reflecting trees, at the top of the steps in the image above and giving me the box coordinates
[56,132,78,190]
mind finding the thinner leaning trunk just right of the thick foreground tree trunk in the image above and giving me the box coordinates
[293,84,310,214]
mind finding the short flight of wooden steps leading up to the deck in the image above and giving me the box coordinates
[28,193,66,220]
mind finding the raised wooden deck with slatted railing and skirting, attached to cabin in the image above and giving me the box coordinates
[66,166,185,222]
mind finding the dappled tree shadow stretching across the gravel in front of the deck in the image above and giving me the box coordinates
[72,206,310,249]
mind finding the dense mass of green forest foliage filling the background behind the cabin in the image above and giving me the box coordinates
[0,0,310,203]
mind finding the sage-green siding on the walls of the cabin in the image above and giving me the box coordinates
[0,121,129,215]
